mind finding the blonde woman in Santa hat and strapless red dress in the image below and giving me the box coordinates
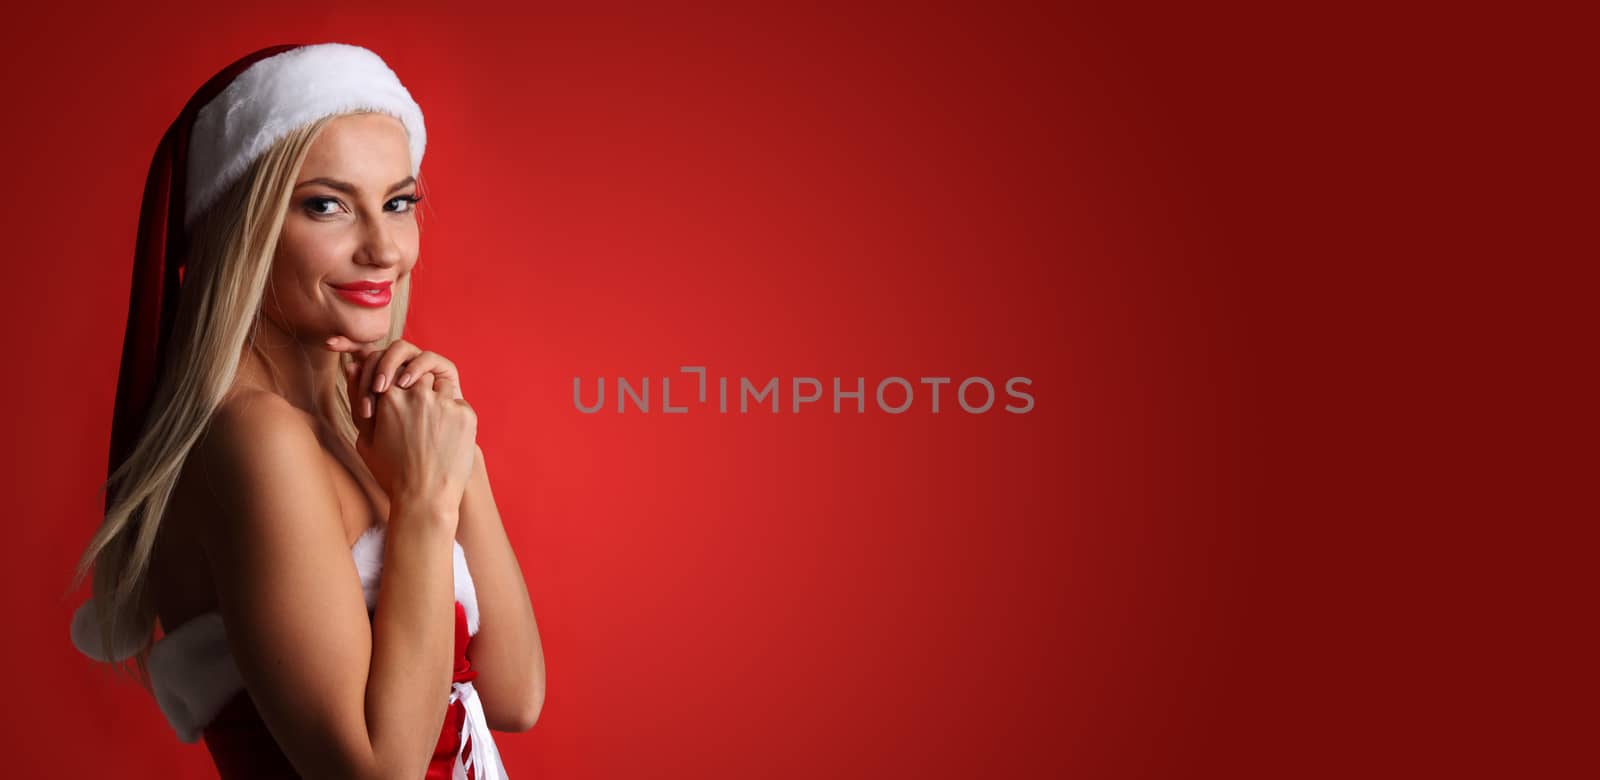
[72,43,544,780]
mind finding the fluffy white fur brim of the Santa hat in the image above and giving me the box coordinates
[184,43,427,227]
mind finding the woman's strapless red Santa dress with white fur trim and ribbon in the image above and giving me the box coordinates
[72,526,507,780]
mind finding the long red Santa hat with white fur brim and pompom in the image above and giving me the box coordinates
[74,43,427,660]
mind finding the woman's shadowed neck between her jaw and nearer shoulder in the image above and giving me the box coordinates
[234,316,344,419]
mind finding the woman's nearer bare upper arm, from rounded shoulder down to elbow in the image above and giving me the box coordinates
[197,392,385,777]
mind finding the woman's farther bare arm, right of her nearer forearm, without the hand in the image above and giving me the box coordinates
[456,448,544,732]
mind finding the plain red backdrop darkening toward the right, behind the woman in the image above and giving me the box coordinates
[0,3,1595,778]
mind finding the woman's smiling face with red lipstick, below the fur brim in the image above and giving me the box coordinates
[262,113,418,344]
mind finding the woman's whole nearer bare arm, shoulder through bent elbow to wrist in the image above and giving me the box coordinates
[195,393,456,778]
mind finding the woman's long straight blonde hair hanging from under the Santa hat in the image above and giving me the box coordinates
[72,112,411,692]
